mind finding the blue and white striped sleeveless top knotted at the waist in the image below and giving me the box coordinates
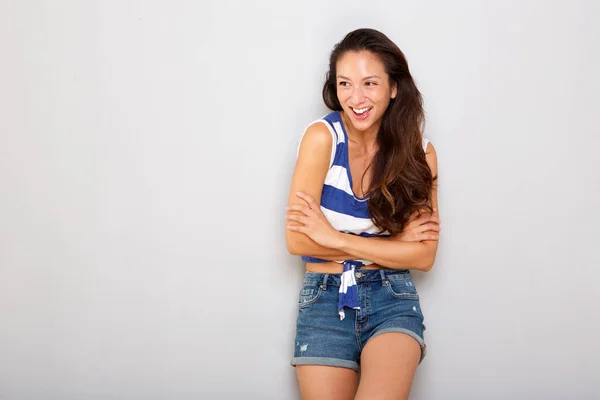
[298,111,429,319]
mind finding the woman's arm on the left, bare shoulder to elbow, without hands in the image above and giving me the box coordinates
[285,122,352,261]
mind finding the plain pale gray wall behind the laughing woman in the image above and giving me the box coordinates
[0,0,600,400]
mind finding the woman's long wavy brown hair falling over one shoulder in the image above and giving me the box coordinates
[323,29,437,234]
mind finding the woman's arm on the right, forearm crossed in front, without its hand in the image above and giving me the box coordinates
[335,143,438,271]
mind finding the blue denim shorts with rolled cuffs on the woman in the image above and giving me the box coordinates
[292,269,426,371]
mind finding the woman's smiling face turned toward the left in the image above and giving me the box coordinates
[336,51,397,131]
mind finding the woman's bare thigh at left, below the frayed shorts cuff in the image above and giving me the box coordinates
[296,366,358,400]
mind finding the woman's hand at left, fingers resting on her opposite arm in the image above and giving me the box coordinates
[286,192,343,249]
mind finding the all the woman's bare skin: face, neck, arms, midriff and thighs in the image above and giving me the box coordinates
[286,51,440,400]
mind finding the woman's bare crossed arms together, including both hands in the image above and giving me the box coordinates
[286,123,439,271]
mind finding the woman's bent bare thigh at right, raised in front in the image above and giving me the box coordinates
[355,332,421,400]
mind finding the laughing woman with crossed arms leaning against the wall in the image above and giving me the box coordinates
[286,29,439,400]
